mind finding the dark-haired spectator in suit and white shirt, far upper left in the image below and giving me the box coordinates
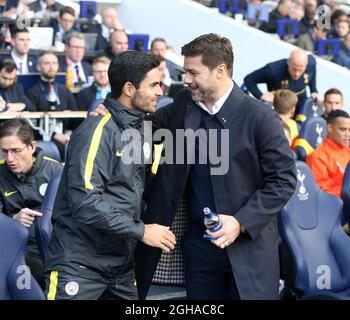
[1,27,36,74]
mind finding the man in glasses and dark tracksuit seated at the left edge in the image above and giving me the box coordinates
[0,118,63,283]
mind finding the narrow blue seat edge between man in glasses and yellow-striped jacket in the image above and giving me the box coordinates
[35,174,61,265]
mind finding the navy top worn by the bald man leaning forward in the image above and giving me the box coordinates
[244,55,317,114]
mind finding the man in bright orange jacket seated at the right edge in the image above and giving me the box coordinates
[306,110,350,197]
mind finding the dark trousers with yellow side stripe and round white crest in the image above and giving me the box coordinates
[45,271,138,300]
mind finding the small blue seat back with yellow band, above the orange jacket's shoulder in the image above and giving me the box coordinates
[294,117,327,161]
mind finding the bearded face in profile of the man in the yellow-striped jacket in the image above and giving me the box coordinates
[131,68,163,112]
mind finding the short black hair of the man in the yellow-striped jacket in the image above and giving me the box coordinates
[108,51,160,99]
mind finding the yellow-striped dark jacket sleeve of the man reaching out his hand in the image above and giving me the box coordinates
[65,114,144,240]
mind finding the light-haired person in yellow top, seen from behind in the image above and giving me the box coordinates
[273,89,299,145]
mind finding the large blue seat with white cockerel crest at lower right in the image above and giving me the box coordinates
[279,161,350,299]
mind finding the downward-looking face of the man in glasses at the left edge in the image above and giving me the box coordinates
[0,135,36,174]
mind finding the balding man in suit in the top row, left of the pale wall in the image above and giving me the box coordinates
[89,7,124,50]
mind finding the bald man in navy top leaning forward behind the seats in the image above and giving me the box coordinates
[244,49,322,114]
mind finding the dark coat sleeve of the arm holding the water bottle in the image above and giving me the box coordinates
[234,111,296,239]
